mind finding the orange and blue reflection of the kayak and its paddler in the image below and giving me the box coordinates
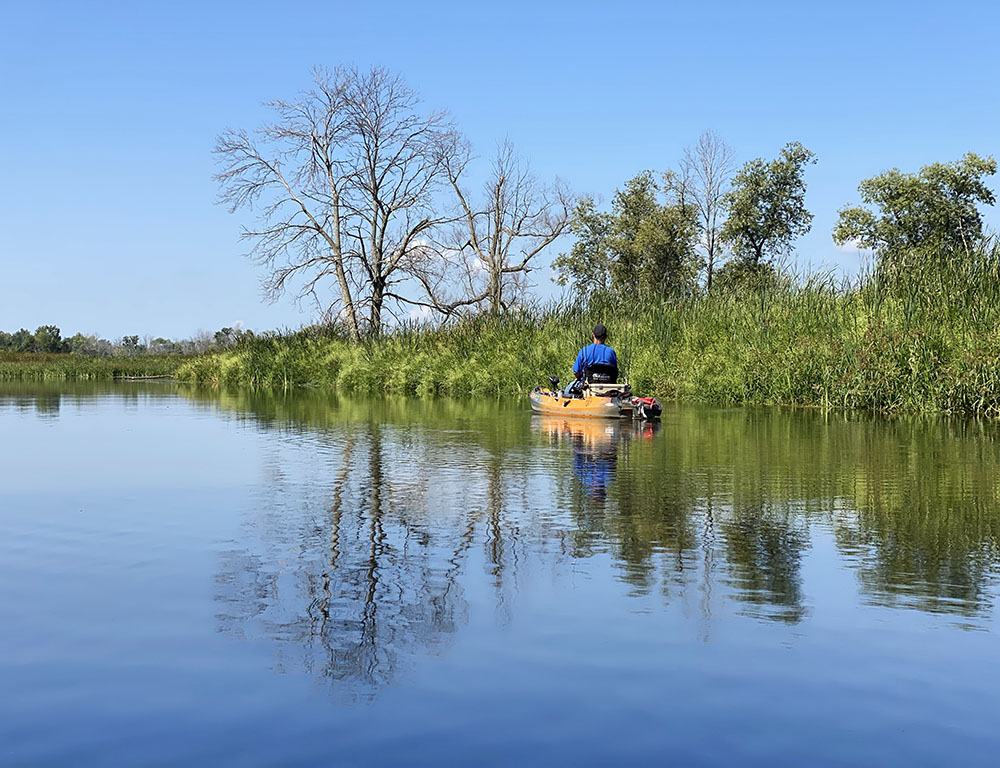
[531,415,660,501]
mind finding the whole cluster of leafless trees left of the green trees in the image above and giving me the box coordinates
[215,68,568,340]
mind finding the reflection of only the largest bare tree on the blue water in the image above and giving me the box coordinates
[216,422,473,697]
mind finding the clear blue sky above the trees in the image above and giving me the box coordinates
[0,0,1000,338]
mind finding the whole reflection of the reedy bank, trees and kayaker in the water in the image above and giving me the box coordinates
[176,391,1000,695]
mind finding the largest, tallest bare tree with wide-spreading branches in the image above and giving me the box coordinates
[215,69,457,339]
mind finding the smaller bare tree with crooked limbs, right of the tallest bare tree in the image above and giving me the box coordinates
[423,140,570,315]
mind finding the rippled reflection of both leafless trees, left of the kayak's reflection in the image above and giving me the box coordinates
[216,402,540,697]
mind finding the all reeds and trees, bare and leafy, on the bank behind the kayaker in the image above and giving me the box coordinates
[177,68,1000,416]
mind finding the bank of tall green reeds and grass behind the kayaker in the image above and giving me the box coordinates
[177,248,1000,416]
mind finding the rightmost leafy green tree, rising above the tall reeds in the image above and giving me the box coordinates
[833,152,997,263]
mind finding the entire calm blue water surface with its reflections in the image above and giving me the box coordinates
[0,384,1000,766]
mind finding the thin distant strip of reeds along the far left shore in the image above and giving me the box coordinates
[0,351,191,381]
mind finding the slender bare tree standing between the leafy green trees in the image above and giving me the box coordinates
[679,131,735,293]
